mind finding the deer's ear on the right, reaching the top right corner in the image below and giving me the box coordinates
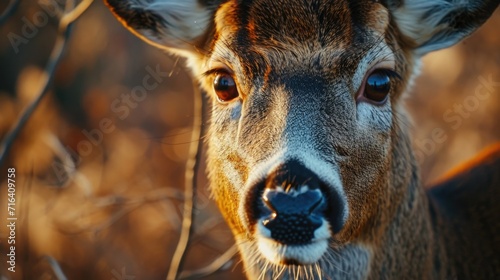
[385,0,500,55]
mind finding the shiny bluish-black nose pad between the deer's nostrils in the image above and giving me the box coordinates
[262,186,326,245]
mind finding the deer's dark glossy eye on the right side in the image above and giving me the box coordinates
[363,69,398,103]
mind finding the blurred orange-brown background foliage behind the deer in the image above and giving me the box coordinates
[0,0,500,280]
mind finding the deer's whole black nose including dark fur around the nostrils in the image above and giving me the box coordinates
[247,159,344,245]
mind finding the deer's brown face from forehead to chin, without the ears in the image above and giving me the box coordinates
[199,1,402,264]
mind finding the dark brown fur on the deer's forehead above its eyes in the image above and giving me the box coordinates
[214,0,389,79]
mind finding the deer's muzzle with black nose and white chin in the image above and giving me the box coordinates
[247,159,345,265]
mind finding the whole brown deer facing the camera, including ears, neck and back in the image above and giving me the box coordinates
[104,0,500,279]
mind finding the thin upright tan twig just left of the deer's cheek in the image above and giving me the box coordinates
[167,82,203,280]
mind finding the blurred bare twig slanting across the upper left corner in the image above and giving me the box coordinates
[0,0,94,166]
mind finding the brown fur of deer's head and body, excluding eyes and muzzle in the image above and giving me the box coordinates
[106,0,500,279]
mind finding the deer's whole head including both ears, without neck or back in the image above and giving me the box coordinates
[107,0,496,275]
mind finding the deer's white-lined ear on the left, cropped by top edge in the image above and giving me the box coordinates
[104,0,217,54]
